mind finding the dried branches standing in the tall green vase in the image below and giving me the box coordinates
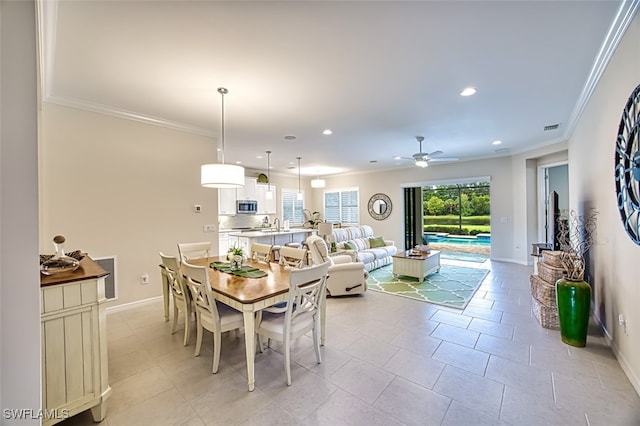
[558,210,598,281]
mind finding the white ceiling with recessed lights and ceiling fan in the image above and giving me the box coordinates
[39,0,621,176]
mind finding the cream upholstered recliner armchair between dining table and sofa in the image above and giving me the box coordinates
[306,235,368,296]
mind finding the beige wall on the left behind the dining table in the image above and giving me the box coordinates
[40,103,312,305]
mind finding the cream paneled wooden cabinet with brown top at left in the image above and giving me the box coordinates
[40,256,111,425]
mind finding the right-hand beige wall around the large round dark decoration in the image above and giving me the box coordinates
[569,16,640,392]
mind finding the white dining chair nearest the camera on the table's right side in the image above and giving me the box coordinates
[256,262,329,386]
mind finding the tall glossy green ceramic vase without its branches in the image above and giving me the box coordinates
[556,278,591,347]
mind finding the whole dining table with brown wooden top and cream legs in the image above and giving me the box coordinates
[184,256,326,391]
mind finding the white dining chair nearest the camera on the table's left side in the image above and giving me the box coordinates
[182,262,244,374]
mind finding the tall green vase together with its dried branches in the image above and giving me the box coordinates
[556,210,598,347]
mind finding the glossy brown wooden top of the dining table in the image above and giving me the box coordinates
[188,256,291,304]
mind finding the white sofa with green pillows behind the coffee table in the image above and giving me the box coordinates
[328,225,398,271]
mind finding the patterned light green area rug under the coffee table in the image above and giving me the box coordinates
[367,265,489,309]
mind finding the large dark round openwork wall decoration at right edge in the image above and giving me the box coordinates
[615,84,640,245]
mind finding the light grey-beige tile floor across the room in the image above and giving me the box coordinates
[61,261,640,426]
